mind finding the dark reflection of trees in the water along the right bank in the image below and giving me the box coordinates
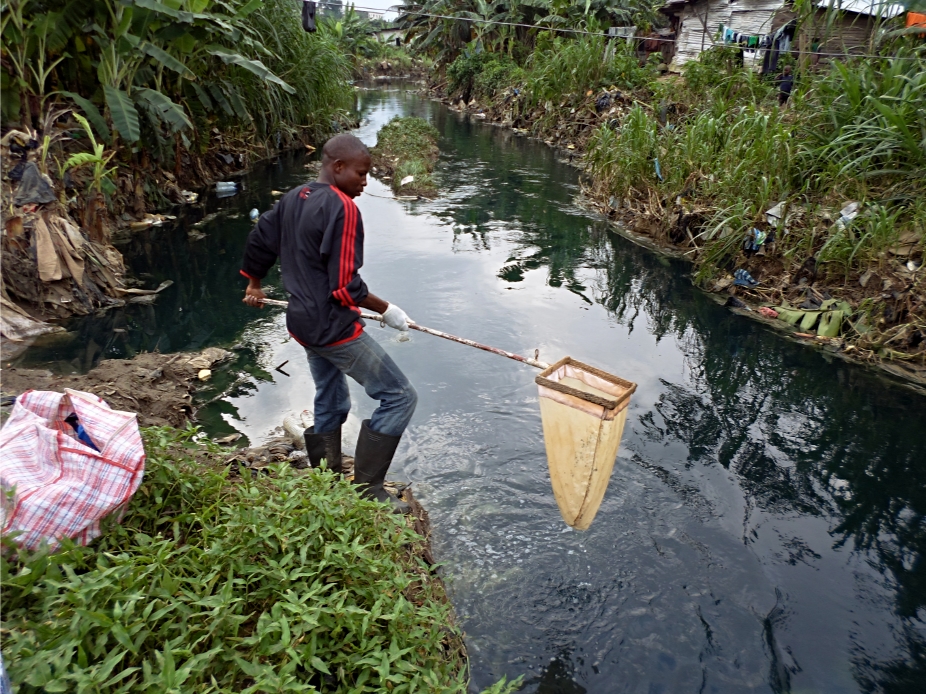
[598,230,926,691]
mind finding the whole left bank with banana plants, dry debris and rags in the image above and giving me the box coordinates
[0,0,352,334]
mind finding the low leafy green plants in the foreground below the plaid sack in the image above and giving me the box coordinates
[0,428,520,693]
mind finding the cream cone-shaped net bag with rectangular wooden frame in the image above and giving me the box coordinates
[535,357,637,530]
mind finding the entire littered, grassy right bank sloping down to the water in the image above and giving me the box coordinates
[400,3,926,389]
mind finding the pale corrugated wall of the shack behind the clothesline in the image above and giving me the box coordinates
[670,0,784,69]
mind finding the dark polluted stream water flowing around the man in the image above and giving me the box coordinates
[19,90,926,694]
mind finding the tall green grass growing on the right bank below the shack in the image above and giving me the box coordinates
[587,49,926,290]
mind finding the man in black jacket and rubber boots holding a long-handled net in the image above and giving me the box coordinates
[241,134,418,512]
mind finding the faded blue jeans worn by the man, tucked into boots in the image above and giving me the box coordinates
[305,333,418,436]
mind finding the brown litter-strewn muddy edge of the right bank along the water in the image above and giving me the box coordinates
[428,83,926,390]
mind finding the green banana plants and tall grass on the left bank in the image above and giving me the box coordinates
[0,0,350,171]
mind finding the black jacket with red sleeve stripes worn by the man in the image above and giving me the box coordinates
[241,182,369,346]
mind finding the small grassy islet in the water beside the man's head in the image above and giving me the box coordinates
[370,116,438,196]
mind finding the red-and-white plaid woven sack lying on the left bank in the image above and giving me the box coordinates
[0,390,145,549]
